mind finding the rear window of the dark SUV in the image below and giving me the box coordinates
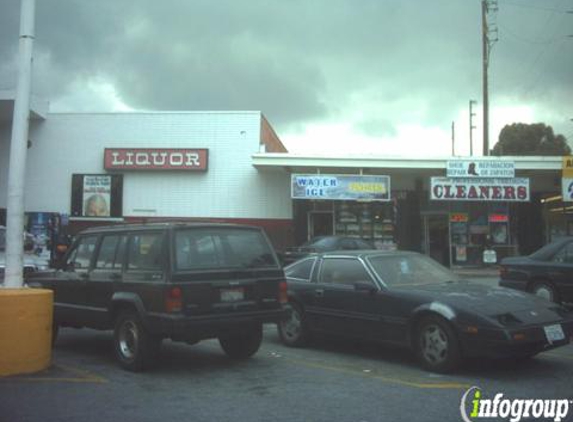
[175,228,278,271]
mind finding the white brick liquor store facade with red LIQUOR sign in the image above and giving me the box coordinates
[0,100,292,248]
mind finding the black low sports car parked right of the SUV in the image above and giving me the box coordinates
[278,250,573,372]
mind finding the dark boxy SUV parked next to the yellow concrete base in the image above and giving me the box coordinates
[28,223,286,371]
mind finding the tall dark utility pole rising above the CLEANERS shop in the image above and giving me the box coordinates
[481,0,497,156]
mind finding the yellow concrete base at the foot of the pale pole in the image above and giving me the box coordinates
[0,288,54,376]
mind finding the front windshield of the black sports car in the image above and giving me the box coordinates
[367,254,461,287]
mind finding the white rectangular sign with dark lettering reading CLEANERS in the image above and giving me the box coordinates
[430,177,529,202]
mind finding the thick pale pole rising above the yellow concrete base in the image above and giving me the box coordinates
[4,0,36,288]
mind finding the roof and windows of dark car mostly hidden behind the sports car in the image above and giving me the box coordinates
[283,236,376,265]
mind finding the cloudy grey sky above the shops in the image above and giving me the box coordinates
[0,0,573,155]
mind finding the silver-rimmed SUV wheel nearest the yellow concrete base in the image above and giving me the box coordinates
[114,311,161,372]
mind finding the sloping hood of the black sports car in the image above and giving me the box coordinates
[392,281,556,316]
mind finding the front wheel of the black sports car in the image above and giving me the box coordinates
[416,316,462,373]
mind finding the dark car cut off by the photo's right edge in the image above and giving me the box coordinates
[499,237,573,303]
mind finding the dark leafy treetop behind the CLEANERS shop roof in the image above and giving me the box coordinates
[492,123,571,155]
